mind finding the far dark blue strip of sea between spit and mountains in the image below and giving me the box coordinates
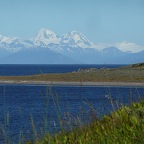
[0,64,124,76]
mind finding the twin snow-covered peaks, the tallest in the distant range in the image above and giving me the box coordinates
[30,28,94,48]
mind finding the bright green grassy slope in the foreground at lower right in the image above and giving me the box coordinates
[27,100,144,144]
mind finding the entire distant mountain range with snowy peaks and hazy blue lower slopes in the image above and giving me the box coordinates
[0,28,144,64]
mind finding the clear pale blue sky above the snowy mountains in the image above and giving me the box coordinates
[0,0,144,45]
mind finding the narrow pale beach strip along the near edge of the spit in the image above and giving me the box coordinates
[0,80,144,86]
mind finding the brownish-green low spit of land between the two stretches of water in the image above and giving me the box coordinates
[0,63,144,83]
